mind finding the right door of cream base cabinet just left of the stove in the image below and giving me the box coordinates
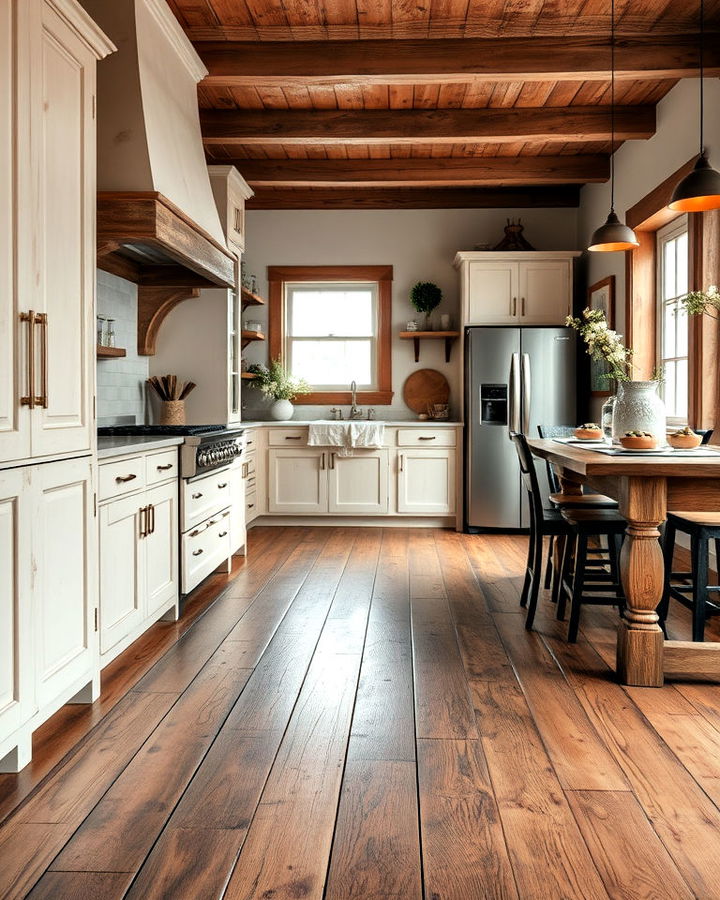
[143,481,180,616]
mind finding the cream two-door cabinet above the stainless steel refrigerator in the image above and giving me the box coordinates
[455,251,579,325]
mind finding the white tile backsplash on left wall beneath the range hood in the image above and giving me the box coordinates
[97,269,149,422]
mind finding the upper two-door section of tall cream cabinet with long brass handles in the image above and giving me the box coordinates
[0,0,114,463]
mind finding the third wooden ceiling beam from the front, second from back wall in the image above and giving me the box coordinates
[226,155,610,189]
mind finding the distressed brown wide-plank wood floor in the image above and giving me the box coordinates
[0,528,720,900]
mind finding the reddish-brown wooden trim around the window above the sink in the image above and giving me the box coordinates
[268,266,393,406]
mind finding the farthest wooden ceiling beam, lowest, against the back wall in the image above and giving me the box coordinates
[246,185,580,209]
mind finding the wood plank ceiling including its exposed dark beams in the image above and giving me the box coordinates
[169,0,720,208]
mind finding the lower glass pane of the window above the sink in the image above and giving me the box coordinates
[290,340,374,387]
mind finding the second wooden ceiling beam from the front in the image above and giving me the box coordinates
[200,106,655,146]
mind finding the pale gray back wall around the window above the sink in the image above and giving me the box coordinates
[243,209,577,419]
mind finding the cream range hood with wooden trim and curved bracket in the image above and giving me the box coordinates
[81,0,236,354]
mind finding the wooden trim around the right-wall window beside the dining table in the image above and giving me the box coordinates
[625,157,720,428]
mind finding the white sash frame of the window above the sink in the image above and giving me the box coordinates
[283,281,380,393]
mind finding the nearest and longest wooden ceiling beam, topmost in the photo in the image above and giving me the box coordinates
[195,34,720,87]
